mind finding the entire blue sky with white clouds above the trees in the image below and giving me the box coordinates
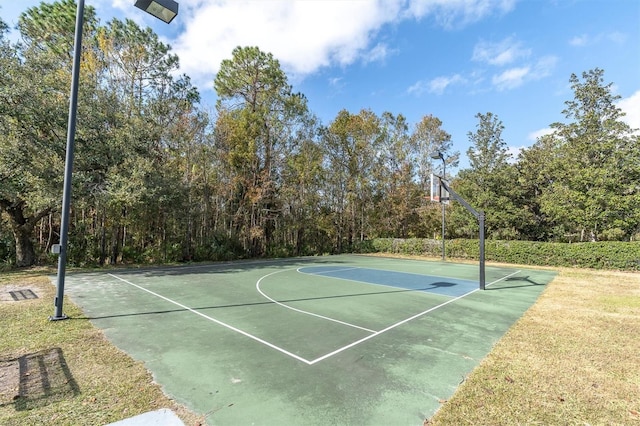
[0,0,640,168]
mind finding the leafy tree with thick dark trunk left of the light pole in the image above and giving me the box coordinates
[0,1,95,266]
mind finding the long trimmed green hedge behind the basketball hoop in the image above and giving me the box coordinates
[360,238,640,271]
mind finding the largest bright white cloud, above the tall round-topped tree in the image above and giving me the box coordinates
[164,0,401,89]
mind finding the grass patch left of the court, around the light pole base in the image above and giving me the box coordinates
[0,271,201,425]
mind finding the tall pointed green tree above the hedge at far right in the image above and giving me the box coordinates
[541,68,640,241]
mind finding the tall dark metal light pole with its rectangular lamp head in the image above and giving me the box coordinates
[49,0,178,321]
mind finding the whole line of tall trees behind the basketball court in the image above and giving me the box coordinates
[0,0,640,266]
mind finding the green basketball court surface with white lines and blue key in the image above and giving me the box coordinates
[66,255,555,425]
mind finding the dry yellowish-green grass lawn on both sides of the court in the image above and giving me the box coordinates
[0,265,640,426]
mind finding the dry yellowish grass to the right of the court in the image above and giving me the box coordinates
[425,269,640,425]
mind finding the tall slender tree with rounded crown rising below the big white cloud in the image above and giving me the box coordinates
[214,47,307,256]
